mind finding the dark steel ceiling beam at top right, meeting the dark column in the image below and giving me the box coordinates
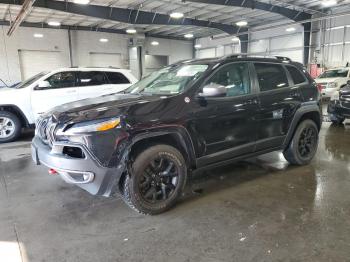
[186,0,311,21]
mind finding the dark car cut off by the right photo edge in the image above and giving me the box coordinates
[327,81,350,124]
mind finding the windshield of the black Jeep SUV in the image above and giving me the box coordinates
[125,65,208,95]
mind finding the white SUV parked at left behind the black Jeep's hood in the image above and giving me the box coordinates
[0,68,137,143]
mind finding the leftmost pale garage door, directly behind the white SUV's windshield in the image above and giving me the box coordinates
[18,50,69,80]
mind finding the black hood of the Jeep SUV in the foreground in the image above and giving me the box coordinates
[46,94,160,123]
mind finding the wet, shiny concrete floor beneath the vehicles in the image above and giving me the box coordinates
[0,123,350,262]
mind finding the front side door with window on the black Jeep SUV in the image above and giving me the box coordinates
[193,63,258,166]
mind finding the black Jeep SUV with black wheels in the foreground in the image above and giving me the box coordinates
[32,55,322,214]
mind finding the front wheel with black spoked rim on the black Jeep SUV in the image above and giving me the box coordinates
[122,145,187,215]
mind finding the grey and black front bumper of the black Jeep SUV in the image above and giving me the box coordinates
[32,136,125,196]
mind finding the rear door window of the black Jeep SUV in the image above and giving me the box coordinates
[254,63,288,92]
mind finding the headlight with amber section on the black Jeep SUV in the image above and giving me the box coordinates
[64,117,120,135]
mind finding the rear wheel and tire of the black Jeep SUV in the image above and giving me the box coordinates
[283,120,319,166]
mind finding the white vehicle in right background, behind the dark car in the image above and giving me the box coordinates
[315,67,350,98]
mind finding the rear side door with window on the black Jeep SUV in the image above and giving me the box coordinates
[254,62,302,151]
